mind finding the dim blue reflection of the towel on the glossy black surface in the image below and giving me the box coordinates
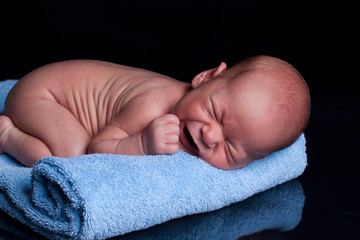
[0,180,305,240]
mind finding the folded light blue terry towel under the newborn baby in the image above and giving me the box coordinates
[0,81,307,239]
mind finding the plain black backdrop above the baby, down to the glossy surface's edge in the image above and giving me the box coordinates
[0,0,358,96]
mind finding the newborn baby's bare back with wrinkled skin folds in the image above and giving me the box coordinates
[7,60,184,136]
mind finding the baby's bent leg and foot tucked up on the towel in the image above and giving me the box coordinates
[0,97,90,166]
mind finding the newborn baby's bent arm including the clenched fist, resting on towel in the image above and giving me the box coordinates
[89,114,180,155]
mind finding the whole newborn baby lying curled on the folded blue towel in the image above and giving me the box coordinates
[0,55,310,169]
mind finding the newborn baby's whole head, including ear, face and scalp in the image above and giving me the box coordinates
[173,55,310,169]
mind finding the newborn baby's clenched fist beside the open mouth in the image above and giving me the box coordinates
[142,114,180,155]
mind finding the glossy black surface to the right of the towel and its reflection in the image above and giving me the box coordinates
[291,96,360,239]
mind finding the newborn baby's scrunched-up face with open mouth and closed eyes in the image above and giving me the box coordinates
[173,74,272,169]
